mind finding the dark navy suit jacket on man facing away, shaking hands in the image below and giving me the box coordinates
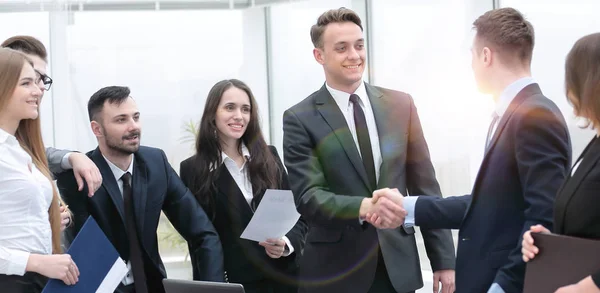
[415,84,571,293]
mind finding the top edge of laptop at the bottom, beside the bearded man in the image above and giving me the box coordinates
[163,279,244,293]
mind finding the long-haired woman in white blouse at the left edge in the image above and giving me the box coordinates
[0,48,79,293]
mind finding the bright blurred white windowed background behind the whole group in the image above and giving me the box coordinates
[0,0,600,292]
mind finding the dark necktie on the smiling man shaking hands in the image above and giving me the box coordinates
[350,94,377,190]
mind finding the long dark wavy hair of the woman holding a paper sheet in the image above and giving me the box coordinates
[189,79,283,218]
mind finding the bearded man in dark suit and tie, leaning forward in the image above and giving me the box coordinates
[58,86,224,293]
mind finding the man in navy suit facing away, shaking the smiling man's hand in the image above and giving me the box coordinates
[369,8,571,293]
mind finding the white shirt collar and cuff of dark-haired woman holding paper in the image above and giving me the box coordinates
[221,143,294,256]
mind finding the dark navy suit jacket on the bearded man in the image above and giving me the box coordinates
[58,146,224,292]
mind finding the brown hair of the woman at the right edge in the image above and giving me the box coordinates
[565,33,600,128]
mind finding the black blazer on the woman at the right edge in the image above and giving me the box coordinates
[554,137,600,287]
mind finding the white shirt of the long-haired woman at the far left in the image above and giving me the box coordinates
[0,129,52,276]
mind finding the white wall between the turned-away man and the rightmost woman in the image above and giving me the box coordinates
[501,0,600,162]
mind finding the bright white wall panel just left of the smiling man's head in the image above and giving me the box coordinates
[269,0,352,156]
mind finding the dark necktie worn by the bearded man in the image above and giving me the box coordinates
[121,172,148,293]
